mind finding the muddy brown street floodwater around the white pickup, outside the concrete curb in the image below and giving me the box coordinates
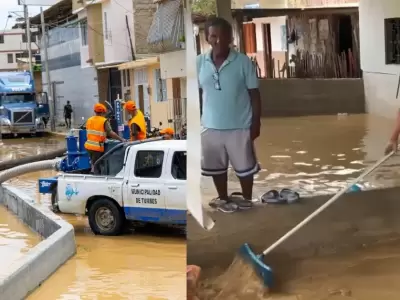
[0,138,186,300]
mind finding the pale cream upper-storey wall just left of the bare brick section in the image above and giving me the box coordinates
[101,0,133,63]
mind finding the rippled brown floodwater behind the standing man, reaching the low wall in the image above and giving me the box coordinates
[216,115,400,196]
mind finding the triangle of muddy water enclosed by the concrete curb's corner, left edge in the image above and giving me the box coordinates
[0,205,40,268]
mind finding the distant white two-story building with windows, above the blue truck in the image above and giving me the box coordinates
[0,28,39,71]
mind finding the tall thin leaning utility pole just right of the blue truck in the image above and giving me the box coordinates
[40,7,56,131]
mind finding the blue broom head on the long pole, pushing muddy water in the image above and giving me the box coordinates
[239,243,273,288]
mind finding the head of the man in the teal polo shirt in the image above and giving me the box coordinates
[205,18,233,54]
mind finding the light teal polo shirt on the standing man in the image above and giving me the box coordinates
[197,49,258,130]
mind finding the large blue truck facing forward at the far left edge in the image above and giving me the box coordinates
[0,71,50,136]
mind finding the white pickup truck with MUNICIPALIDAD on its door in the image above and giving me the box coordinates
[52,140,186,235]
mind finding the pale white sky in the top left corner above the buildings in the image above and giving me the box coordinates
[0,0,53,31]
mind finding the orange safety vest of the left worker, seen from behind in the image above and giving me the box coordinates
[85,116,107,152]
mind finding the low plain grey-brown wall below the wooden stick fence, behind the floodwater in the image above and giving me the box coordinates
[260,79,365,117]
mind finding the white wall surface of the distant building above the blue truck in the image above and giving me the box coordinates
[0,28,38,70]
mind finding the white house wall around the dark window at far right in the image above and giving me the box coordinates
[359,0,400,118]
